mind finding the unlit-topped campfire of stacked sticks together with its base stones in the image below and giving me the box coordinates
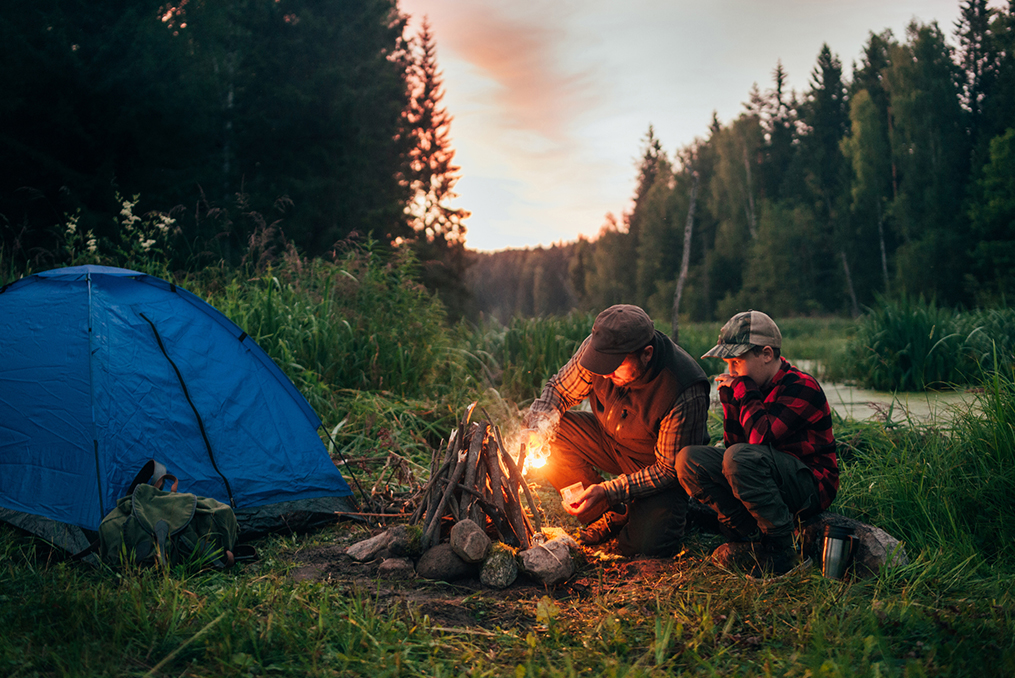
[345,403,579,589]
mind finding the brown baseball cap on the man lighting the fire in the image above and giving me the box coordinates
[579,303,656,375]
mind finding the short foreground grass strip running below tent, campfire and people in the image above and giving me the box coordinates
[0,515,1015,676]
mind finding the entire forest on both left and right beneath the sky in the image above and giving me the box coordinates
[0,0,1015,322]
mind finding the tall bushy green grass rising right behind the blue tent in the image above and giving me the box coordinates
[208,249,451,408]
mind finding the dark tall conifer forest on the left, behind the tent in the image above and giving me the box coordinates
[0,0,468,307]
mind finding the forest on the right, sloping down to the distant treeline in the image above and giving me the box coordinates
[469,0,1015,322]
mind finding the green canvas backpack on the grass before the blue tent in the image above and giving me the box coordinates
[98,474,240,567]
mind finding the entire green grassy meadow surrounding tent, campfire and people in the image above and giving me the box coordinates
[0,246,1015,678]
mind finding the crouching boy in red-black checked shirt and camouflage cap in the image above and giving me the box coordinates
[677,311,838,577]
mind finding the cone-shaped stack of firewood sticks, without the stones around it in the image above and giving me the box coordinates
[410,403,542,551]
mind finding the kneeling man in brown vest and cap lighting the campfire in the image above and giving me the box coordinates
[525,304,708,556]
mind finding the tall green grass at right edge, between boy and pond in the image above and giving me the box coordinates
[834,370,1015,568]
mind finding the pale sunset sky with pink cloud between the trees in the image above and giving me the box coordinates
[399,0,982,252]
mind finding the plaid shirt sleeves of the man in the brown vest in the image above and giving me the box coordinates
[527,339,708,504]
